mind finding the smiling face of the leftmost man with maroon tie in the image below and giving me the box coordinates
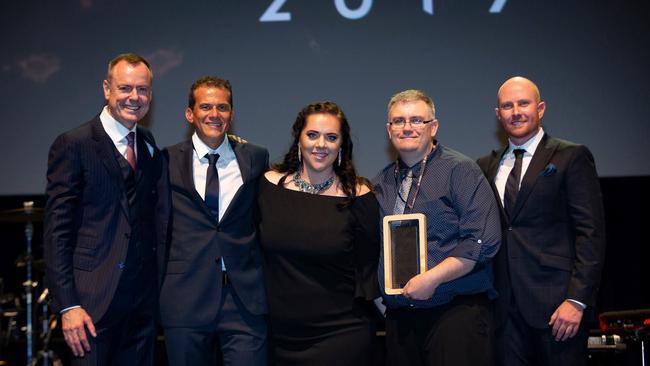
[102,60,151,129]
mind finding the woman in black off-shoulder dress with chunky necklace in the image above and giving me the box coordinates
[259,102,379,366]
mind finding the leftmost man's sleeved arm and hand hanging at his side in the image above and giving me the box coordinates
[43,135,96,357]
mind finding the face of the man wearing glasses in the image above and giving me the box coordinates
[386,100,438,166]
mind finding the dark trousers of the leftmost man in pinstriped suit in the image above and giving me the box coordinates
[71,260,158,366]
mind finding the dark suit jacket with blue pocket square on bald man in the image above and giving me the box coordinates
[478,134,605,328]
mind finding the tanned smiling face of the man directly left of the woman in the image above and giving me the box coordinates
[185,86,233,149]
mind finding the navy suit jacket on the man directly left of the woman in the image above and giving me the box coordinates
[160,140,269,327]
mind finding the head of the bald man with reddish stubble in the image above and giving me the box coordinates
[495,77,546,145]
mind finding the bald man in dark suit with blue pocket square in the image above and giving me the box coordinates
[478,77,605,366]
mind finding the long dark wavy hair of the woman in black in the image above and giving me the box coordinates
[272,101,370,199]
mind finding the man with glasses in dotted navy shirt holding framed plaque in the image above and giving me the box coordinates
[374,90,501,366]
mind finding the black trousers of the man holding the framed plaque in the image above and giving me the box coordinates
[386,294,494,366]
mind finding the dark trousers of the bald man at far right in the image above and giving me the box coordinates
[496,308,589,366]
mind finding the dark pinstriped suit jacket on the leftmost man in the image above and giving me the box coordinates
[44,116,168,322]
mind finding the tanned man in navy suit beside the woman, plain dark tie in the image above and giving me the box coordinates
[160,77,268,366]
